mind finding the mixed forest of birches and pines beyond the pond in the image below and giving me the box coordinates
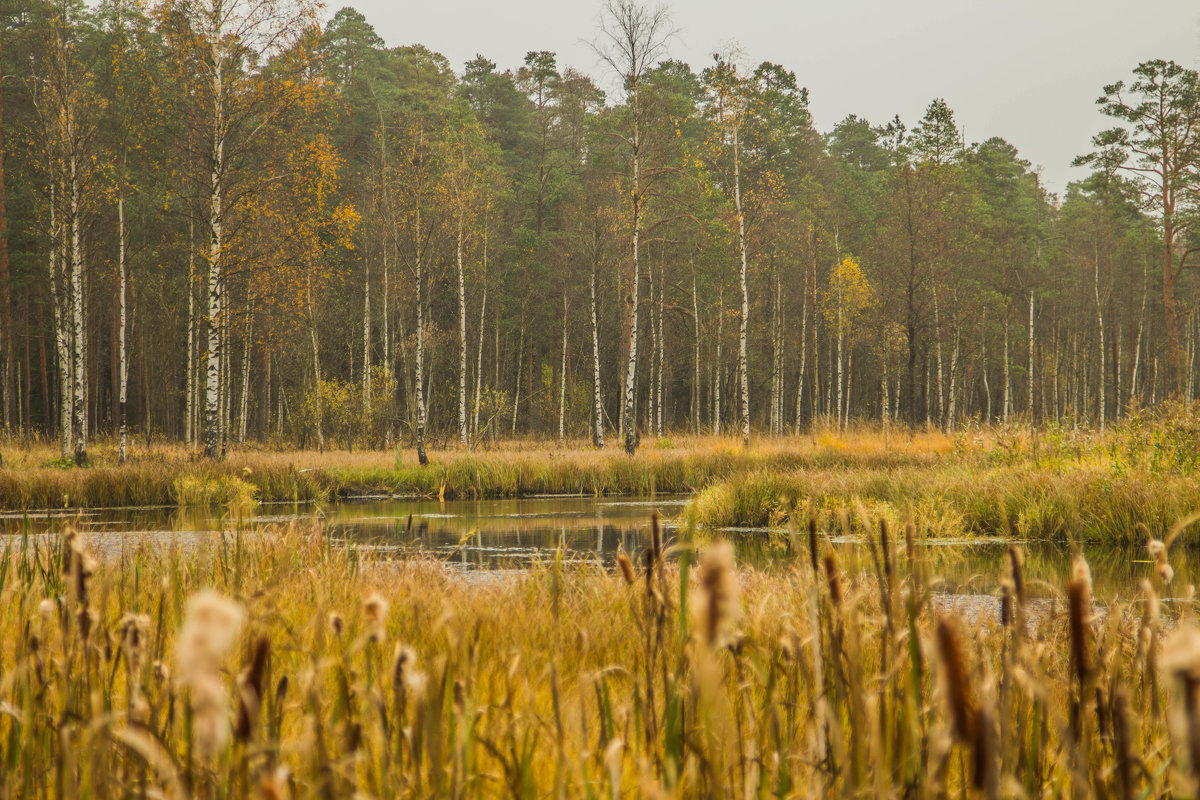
[0,0,1200,461]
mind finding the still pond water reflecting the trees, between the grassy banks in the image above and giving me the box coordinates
[0,495,1185,597]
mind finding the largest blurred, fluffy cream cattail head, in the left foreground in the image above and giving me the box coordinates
[175,589,244,756]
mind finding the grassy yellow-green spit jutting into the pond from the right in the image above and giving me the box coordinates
[685,462,1200,542]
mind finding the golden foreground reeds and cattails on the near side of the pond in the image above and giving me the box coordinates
[0,515,1200,799]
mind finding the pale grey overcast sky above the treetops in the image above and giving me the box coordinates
[336,0,1200,192]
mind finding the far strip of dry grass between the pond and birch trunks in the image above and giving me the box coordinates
[0,431,954,510]
